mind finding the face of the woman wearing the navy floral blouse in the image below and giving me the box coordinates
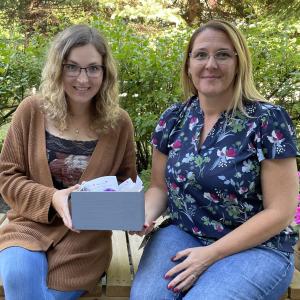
[188,29,237,102]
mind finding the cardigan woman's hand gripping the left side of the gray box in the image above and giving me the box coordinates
[52,184,79,232]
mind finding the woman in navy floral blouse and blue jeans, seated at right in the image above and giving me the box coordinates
[130,20,298,300]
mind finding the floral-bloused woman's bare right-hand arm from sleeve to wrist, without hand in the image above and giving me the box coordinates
[213,158,299,259]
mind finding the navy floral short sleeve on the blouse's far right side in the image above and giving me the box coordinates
[255,105,299,161]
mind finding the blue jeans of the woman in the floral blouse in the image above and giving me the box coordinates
[130,225,294,300]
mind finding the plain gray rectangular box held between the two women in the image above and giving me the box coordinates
[70,192,145,231]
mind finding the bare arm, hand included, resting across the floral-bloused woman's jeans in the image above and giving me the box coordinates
[166,158,298,290]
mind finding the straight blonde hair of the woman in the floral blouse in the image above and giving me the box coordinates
[181,20,266,113]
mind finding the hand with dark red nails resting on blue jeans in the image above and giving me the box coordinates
[165,246,217,292]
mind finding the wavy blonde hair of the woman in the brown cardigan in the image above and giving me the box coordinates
[39,25,120,133]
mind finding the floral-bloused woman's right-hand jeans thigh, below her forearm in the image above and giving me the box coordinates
[183,247,294,300]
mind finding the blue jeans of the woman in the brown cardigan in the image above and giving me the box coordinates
[0,247,84,300]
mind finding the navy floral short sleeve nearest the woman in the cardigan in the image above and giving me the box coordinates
[151,103,182,155]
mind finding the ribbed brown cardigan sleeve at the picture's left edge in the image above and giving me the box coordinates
[0,98,56,223]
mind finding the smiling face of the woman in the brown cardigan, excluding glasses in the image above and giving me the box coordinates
[62,44,103,105]
